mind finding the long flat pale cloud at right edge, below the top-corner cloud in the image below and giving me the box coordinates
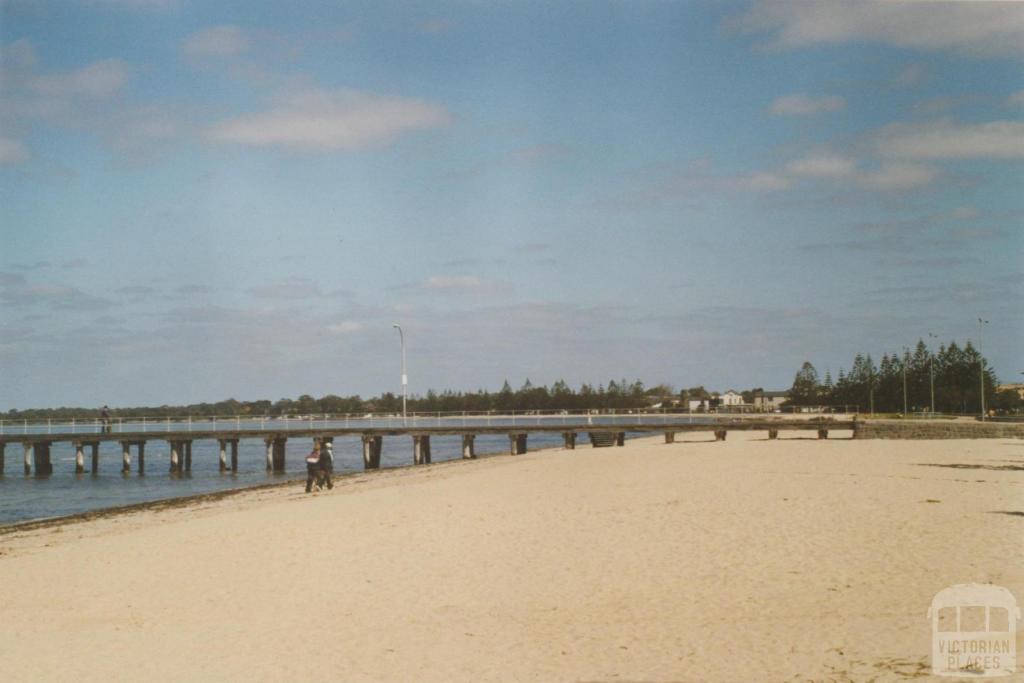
[876,121,1024,160]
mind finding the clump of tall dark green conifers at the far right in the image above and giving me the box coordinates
[788,340,1022,414]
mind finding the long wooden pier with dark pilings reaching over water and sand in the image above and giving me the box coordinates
[0,420,851,476]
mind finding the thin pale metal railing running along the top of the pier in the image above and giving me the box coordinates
[0,410,786,435]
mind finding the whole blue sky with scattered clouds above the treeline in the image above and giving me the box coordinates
[0,0,1024,411]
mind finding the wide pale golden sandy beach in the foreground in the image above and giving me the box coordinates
[0,433,1024,681]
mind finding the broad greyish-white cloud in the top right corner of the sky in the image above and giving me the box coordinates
[729,0,1024,54]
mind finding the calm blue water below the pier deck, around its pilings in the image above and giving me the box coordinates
[0,433,647,524]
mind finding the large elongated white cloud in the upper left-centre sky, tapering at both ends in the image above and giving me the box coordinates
[208,89,451,152]
